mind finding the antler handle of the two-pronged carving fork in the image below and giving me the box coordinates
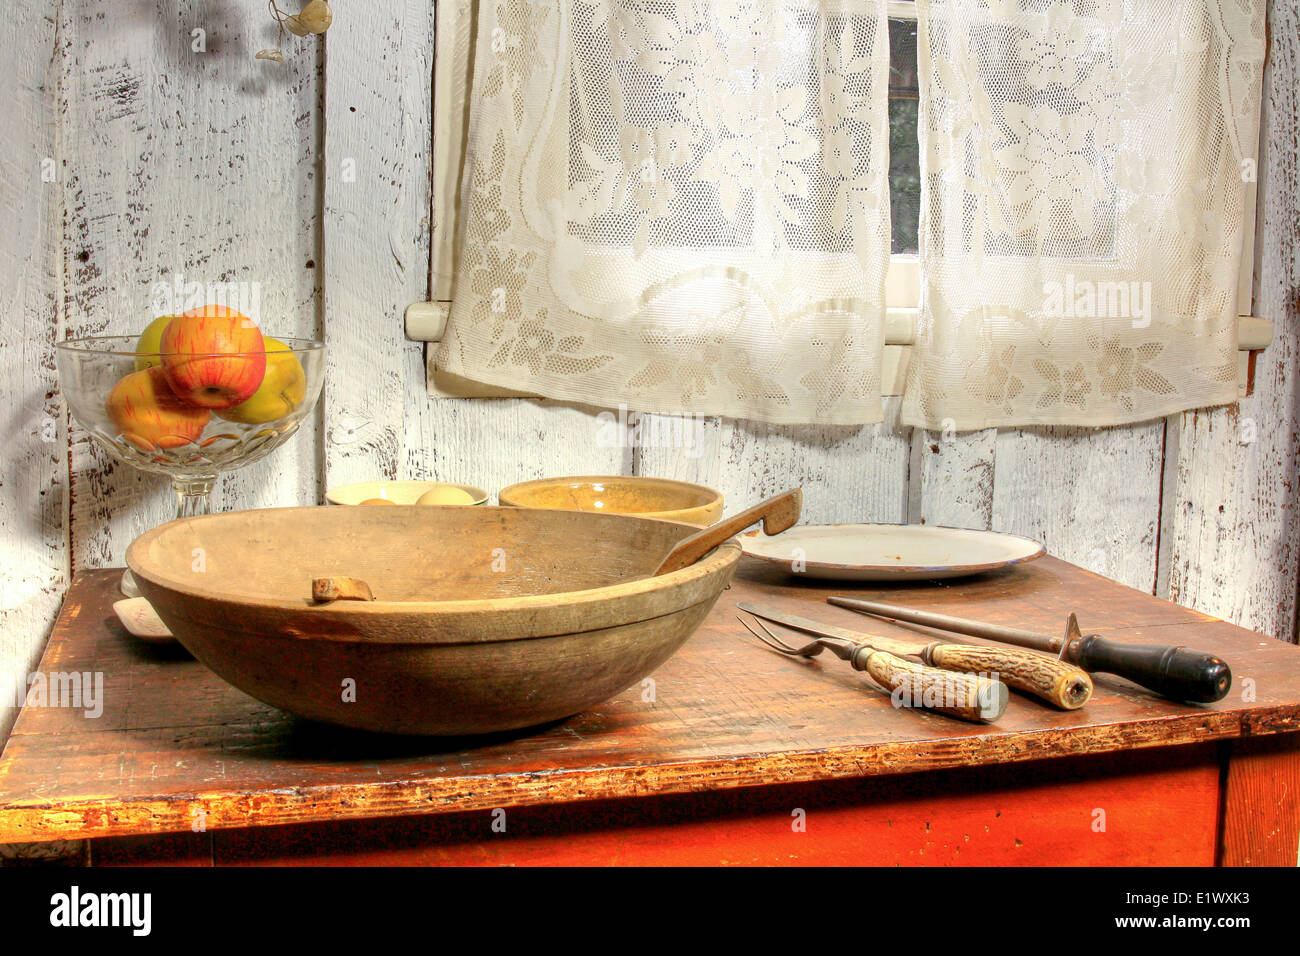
[852,645,1010,723]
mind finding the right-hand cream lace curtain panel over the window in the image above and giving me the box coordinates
[902,0,1264,429]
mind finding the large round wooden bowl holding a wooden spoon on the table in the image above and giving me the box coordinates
[126,506,740,735]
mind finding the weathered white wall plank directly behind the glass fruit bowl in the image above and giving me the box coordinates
[60,0,320,568]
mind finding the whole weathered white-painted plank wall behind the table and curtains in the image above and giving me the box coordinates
[0,0,1300,732]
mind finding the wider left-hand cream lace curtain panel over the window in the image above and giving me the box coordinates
[436,0,889,423]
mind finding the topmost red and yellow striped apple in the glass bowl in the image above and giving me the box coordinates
[160,306,267,408]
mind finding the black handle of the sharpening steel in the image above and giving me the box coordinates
[1069,633,1232,704]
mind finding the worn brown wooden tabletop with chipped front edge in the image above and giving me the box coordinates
[0,558,1300,843]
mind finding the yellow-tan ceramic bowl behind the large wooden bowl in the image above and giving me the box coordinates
[497,475,723,527]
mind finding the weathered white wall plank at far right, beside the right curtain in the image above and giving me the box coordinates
[1169,3,1300,641]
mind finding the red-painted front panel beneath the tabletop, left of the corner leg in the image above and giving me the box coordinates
[90,745,1242,866]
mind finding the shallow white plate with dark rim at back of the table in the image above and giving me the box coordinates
[740,524,1045,581]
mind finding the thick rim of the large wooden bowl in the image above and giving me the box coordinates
[126,505,741,618]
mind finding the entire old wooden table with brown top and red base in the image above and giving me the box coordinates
[0,558,1300,865]
